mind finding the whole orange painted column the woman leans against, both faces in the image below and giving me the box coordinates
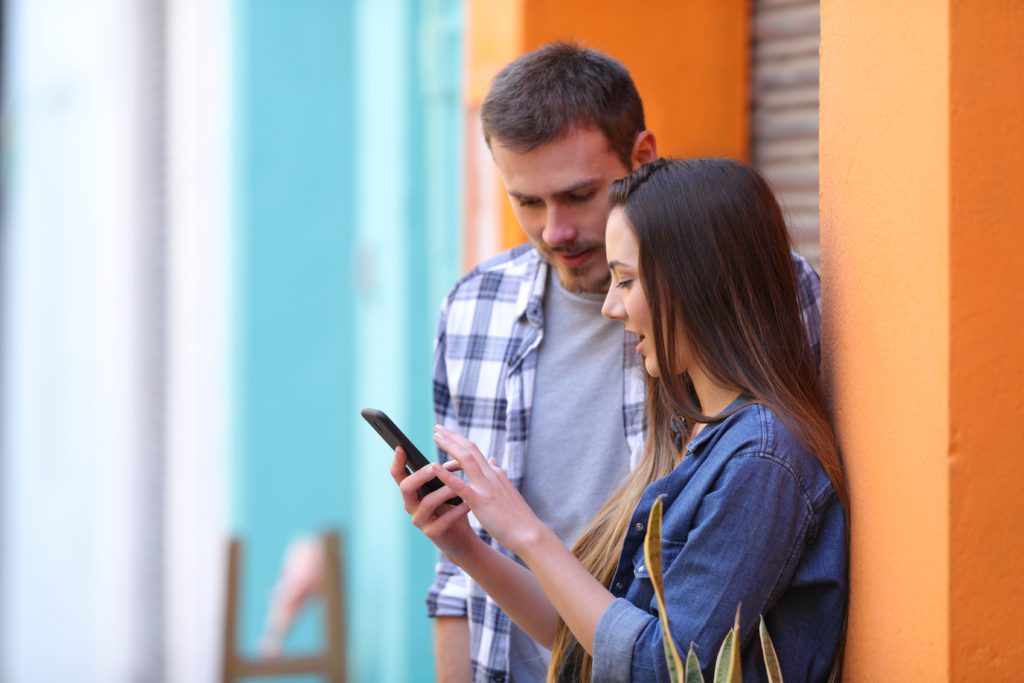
[820,0,1024,681]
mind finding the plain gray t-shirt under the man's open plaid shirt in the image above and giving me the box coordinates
[509,268,630,683]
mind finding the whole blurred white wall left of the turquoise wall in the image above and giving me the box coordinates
[0,0,229,683]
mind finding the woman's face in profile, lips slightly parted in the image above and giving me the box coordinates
[601,207,658,377]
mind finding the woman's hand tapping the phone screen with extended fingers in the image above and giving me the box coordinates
[424,425,545,555]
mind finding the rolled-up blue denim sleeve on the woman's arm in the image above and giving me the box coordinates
[593,454,812,682]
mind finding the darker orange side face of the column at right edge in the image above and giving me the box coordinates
[949,0,1024,681]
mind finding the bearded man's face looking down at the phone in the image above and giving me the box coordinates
[490,128,630,293]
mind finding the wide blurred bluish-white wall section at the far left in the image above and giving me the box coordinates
[0,0,151,682]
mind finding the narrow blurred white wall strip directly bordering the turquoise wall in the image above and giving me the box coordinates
[166,0,232,682]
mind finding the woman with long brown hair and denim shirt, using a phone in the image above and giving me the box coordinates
[392,159,848,683]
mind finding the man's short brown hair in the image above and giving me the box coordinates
[480,42,645,169]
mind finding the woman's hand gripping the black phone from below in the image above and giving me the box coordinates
[391,446,485,564]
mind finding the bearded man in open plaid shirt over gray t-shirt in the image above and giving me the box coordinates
[427,44,818,683]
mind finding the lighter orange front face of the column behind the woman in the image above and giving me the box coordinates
[819,0,949,681]
